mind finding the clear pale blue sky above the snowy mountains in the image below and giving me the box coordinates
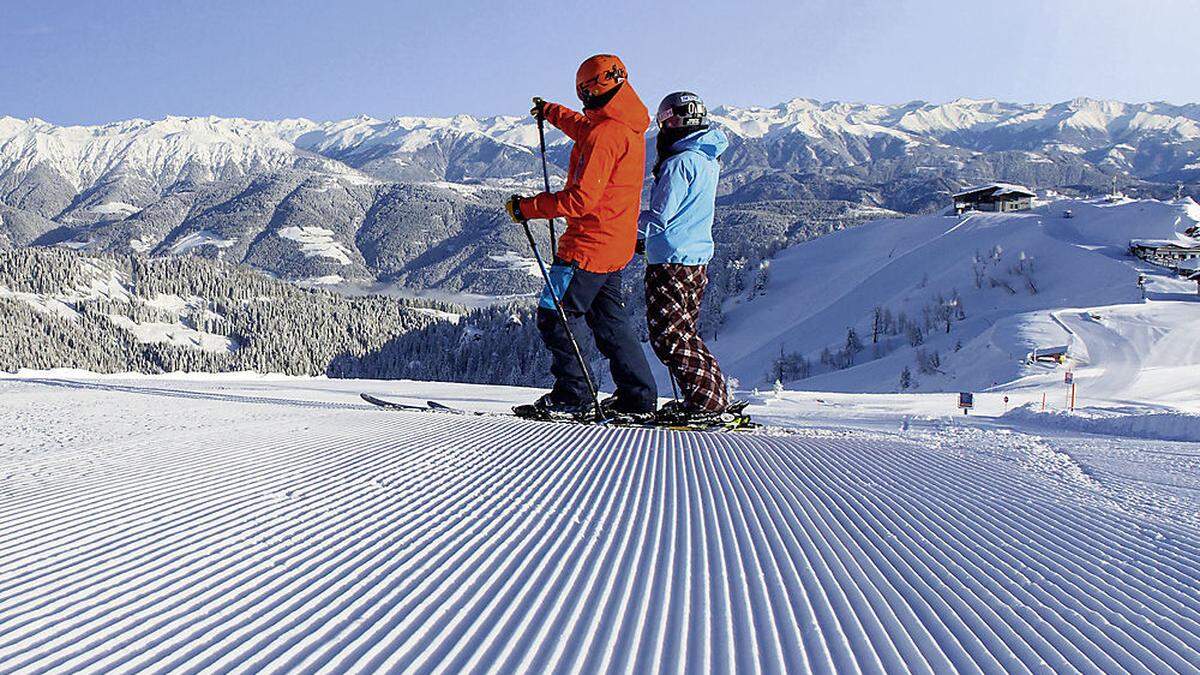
[0,0,1200,124]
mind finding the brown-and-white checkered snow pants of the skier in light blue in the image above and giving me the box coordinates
[646,263,728,412]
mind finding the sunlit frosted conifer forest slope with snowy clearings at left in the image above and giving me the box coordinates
[0,249,444,375]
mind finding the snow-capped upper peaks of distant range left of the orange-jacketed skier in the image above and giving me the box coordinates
[0,115,538,222]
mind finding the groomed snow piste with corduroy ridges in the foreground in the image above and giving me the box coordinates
[0,377,1200,674]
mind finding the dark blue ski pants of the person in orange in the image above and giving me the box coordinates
[538,259,658,412]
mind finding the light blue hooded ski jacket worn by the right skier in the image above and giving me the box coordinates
[637,127,730,265]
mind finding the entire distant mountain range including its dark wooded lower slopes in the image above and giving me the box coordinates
[0,98,1200,292]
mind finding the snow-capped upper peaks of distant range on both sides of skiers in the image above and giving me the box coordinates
[0,98,1200,211]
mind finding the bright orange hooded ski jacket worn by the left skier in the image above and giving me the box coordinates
[520,82,649,274]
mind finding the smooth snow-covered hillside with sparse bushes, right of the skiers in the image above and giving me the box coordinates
[715,194,1200,410]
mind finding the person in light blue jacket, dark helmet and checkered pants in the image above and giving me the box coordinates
[638,91,730,418]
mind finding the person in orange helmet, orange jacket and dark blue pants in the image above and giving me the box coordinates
[505,54,658,417]
